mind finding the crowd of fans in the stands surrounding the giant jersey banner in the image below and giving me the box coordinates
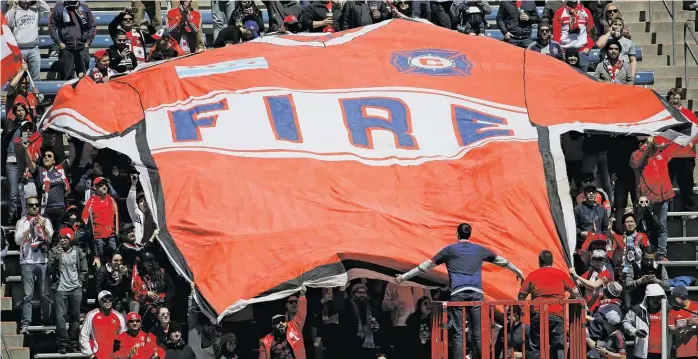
[2,0,698,359]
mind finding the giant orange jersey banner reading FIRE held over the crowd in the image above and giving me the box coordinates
[48,20,685,316]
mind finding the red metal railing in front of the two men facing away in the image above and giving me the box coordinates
[431,299,587,359]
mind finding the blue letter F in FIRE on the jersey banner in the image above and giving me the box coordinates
[168,99,228,142]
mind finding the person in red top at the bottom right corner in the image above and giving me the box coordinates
[668,285,698,359]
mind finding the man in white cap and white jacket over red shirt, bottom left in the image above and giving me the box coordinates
[80,290,126,359]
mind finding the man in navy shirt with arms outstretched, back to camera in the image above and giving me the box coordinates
[395,223,524,359]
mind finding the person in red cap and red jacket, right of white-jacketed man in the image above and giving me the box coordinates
[112,312,165,359]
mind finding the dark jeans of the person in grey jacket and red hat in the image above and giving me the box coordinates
[54,287,82,349]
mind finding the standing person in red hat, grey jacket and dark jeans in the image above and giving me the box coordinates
[46,227,87,354]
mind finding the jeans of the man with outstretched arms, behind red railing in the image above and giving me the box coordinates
[448,291,485,359]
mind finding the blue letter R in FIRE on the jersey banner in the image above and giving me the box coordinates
[339,97,419,150]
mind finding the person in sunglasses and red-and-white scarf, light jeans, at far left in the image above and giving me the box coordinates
[15,197,53,334]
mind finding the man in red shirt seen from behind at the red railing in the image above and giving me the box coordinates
[518,250,582,358]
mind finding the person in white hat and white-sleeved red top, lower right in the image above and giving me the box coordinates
[623,283,666,359]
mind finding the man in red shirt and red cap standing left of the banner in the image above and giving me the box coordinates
[82,177,119,263]
